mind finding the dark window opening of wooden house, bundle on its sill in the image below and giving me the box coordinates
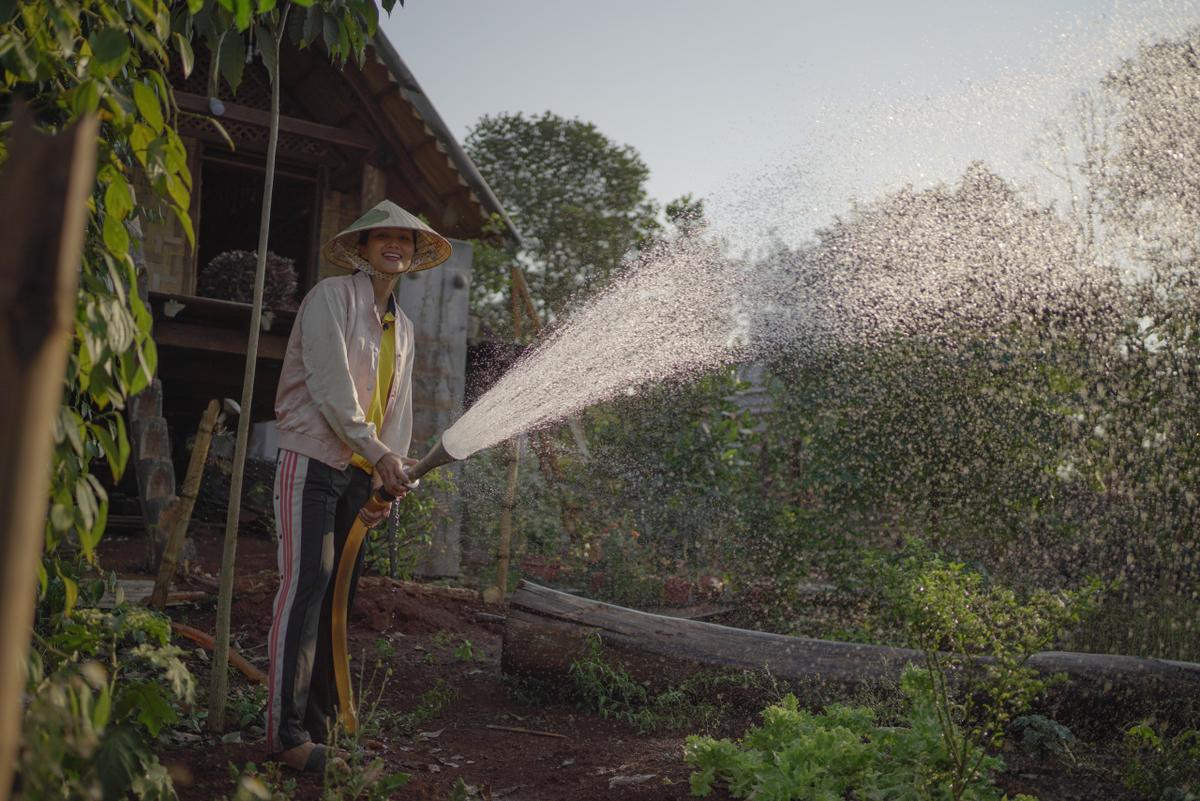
[196,153,319,307]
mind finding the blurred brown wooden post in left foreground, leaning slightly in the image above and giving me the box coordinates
[0,107,97,801]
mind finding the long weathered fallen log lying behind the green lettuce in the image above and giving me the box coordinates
[500,582,1200,734]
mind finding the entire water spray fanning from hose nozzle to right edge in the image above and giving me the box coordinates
[443,6,1200,660]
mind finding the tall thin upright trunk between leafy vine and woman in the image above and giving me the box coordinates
[209,17,290,733]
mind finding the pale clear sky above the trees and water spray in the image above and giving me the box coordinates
[383,0,1200,239]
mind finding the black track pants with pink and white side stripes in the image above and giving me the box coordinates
[266,451,371,751]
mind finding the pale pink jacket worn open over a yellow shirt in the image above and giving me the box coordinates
[275,272,413,470]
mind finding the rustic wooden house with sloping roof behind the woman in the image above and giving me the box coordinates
[130,34,518,574]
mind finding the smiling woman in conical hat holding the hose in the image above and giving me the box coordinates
[266,200,450,771]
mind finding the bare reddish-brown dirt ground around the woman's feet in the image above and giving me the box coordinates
[101,531,1130,801]
